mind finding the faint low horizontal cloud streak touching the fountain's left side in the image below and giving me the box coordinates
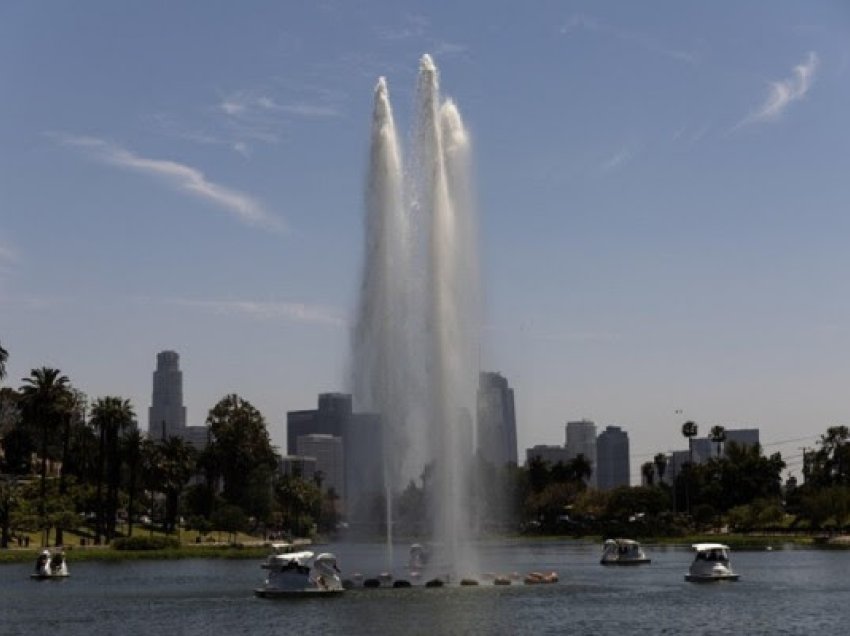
[162,298,346,327]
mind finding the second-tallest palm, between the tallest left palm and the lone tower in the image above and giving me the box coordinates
[92,396,136,543]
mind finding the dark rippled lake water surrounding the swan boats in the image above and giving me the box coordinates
[0,541,850,636]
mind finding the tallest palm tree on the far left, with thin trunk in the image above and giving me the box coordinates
[20,367,71,545]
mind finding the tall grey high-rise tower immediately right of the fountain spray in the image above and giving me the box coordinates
[476,372,517,466]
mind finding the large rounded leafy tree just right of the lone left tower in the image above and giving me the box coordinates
[204,394,277,518]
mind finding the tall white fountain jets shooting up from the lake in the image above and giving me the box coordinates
[352,55,479,574]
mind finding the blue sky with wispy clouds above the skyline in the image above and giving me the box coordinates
[0,0,850,482]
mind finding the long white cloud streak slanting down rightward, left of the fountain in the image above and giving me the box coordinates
[50,133,285,230]
